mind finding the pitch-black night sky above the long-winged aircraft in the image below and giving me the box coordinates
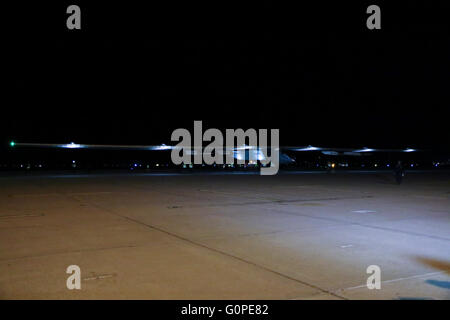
[0,0,450,147]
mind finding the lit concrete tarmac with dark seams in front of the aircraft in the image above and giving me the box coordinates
[0,173,450,299]
